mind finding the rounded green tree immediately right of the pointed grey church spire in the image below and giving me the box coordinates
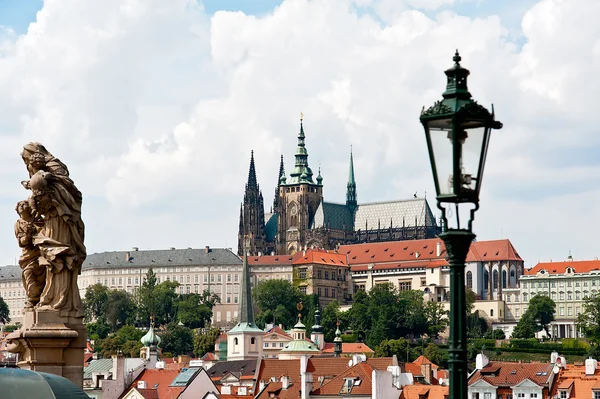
[252,279,303,327]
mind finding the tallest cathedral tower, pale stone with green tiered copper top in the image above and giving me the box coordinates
[277,118,323,255]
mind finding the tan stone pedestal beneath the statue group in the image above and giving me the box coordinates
[7,309,86,387]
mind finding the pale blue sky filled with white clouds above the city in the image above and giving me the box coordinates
[0,0,600,267]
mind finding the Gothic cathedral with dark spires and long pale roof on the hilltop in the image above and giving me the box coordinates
[238,119,441,256]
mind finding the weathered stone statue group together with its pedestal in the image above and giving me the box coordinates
[6,143,86,386]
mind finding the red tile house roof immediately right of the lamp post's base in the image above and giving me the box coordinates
[469,362,552,387]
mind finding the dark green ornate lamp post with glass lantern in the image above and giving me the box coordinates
[420,50,502,399]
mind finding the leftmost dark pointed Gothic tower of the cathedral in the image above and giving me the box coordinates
[238,151,266,256]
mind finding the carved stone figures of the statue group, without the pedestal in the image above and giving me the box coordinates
[15,143,86,317]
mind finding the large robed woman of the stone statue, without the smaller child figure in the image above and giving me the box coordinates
[21,143,86,317]
